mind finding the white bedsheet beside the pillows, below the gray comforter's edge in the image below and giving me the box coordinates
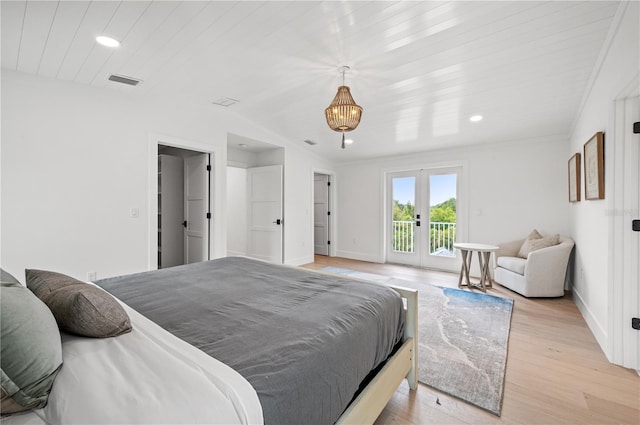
[2,300,263,424]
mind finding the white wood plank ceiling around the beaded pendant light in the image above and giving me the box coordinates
[1,1,624,161]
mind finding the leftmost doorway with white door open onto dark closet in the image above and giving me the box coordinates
[157,144,211,268]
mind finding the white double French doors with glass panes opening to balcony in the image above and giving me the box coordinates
[387,167,463,271]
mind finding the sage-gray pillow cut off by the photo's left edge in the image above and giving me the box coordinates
[0,271,62,416]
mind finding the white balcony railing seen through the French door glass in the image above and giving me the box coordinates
[392,221,456,257]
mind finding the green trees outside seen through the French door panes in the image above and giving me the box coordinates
[392,198,456,253]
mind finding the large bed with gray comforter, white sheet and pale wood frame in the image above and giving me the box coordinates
[2,257,417,424]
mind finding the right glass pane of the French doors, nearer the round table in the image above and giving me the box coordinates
[429,174,457,257]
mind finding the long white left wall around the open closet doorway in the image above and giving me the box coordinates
[0,70,327,280]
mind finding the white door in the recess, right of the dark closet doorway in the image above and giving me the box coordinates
[247,165,284,264]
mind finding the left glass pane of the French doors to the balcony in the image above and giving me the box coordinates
[391,177,416,253]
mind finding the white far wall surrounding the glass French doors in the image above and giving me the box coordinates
[336,137,571,272]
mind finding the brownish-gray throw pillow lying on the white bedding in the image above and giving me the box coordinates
[25,270,131,338]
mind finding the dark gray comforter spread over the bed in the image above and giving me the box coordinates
[96,257,404,425]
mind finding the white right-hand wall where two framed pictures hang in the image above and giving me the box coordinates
[569,2,640,356]
